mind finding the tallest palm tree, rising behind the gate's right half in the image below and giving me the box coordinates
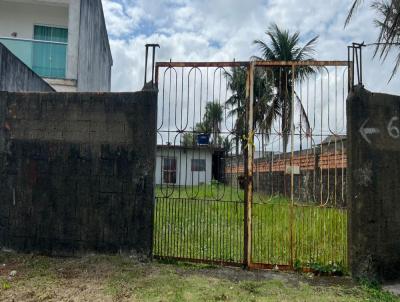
[252,24,318,152]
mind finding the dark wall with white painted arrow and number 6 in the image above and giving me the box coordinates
[347,87,400,280]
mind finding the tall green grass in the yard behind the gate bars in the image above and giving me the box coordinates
[154,185,347,272]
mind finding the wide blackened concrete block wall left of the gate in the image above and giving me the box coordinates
[0,91,156,255]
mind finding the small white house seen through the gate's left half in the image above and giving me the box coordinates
[156,145,215,186]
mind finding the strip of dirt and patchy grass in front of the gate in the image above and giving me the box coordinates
[0,252,400,302]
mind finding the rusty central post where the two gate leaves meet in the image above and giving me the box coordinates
[244,62,254,268]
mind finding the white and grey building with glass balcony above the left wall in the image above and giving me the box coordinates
[0,0,113,92]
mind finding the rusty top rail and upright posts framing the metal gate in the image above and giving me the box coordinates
[154,58,354,270]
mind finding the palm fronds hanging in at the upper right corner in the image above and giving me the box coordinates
[345,0,400,81]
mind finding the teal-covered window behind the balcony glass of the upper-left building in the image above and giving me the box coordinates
[32,25,68,78]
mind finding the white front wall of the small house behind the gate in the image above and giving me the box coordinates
[156,147,213,186]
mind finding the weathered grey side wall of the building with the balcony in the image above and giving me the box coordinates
[78,0,112,91]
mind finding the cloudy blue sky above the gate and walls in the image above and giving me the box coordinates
[102,0,400,93]
